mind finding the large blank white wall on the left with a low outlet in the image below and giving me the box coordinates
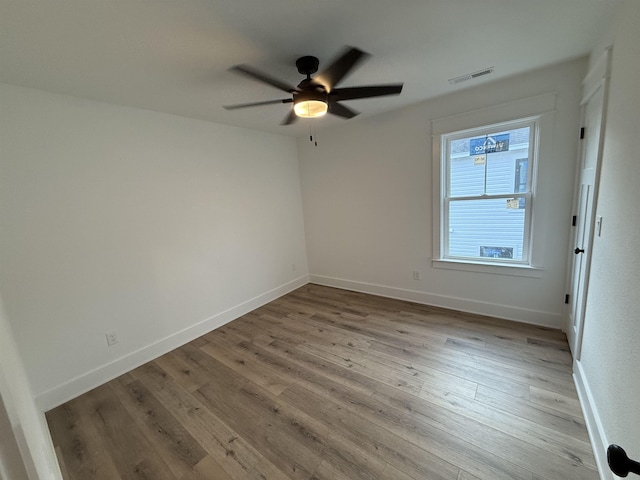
[0,85,307,408]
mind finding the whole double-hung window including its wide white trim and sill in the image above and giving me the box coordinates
[431,93,556,278]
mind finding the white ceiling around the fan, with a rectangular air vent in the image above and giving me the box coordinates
[0,0,617,135]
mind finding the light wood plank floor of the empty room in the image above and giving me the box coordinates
[47,285,598,480]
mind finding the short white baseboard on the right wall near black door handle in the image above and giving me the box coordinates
[573,361,619,480]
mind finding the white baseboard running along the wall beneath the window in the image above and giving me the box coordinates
[309,275,562,329]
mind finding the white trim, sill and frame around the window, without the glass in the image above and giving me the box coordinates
[431,93,556,277]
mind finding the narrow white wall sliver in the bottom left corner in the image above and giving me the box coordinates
[0,298,62,480]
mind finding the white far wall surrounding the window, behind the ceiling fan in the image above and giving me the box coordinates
[298,59,586,328]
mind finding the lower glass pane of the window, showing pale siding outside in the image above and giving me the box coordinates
[449,198,526,261]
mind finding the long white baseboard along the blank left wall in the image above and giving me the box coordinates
[34,275,309,412]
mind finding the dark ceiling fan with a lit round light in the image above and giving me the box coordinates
[224,47,403,125]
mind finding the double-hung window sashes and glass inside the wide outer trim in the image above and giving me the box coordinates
[440,118,538,265]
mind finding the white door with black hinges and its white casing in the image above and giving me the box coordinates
[567,52,608,360]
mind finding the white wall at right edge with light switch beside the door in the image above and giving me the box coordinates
[576,0,640,478]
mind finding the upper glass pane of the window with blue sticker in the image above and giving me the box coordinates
[447,127,531,197]
